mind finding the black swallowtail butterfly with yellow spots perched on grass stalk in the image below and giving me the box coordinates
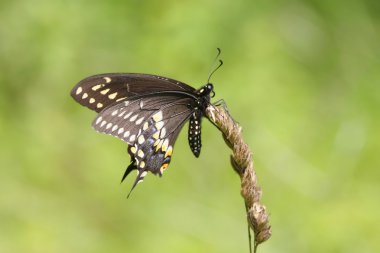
[71,58,222,196]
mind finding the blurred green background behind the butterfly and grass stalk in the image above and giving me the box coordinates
[0,0,380,253]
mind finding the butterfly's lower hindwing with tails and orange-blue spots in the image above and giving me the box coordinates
[93,95,193,196]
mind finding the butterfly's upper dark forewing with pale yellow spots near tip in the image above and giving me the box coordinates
[71,73,195,112]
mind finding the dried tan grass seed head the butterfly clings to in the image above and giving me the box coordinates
[206,105,272,252]
